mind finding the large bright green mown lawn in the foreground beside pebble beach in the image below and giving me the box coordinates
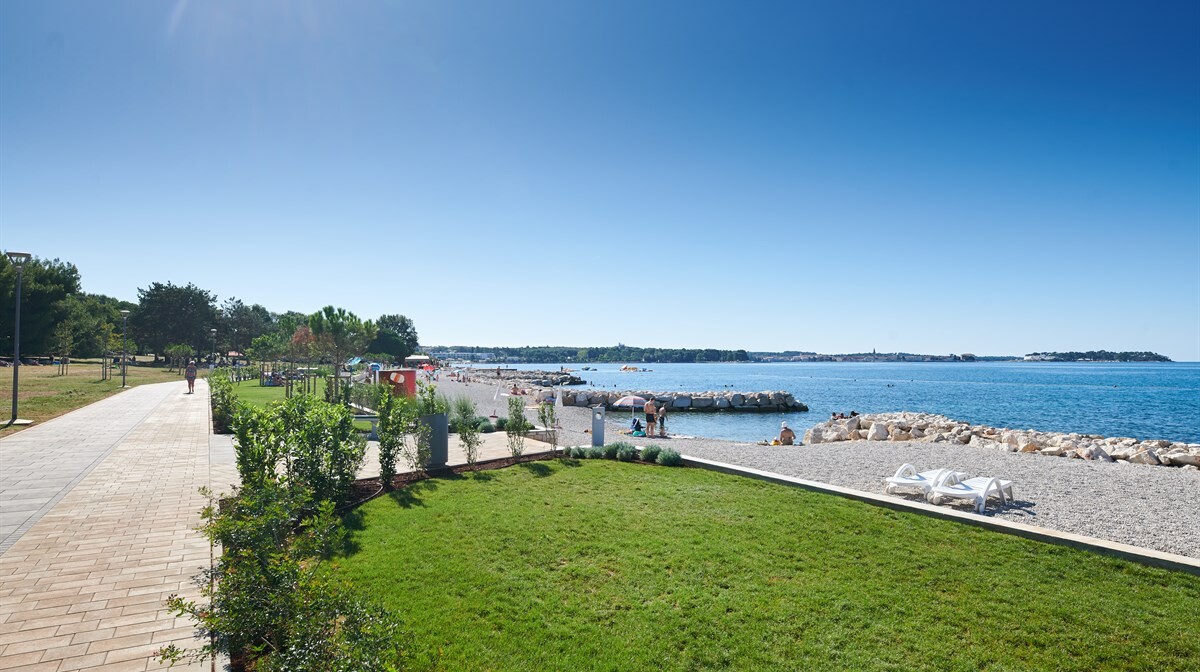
[335,461,1200,671]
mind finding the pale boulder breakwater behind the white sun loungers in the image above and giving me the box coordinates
[804,413,1200,469]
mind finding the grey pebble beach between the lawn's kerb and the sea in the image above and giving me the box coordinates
[439,378,1200,558]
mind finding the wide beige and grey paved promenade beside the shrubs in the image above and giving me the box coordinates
[0,380,236,671]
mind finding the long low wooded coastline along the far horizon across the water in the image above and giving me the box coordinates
[422,343,1171,364]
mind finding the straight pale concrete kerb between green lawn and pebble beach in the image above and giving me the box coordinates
[683,455,1200,576]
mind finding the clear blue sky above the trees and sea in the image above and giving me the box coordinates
[0,0,1200,360]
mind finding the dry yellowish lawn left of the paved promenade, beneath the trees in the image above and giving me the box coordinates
[0,360,184,436]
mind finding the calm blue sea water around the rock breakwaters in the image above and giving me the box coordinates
[477,362,1200,443]
